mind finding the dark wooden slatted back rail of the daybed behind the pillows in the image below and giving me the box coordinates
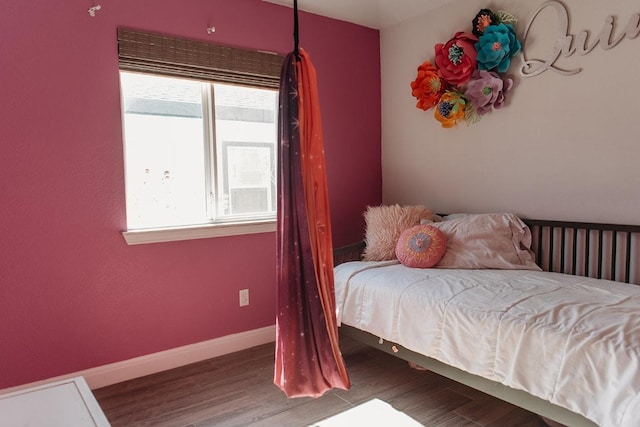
[334,219,640,285]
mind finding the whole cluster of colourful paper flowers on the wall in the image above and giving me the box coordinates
[411,9,522,128]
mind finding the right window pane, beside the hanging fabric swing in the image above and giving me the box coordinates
[214,84,278,219]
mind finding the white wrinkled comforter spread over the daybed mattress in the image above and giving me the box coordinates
[335,262,640,427]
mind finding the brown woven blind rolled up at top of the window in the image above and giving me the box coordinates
[118,28,284,88]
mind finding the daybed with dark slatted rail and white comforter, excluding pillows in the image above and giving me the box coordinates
[334,214,640,427]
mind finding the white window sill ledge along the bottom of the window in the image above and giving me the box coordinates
[122,220,276,245]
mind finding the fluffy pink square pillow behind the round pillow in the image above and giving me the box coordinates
[363,204,434,261]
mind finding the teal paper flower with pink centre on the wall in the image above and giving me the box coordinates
[475,23,521,73]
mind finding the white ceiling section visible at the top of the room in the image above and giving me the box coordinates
[263,0,453,29]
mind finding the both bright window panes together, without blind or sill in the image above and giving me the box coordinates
[120,75,277,230]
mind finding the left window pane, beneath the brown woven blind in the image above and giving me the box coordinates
[120,72,210,229]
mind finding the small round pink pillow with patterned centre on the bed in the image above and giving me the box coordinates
[396,224,447,268]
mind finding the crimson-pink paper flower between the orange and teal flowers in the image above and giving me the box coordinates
[435,32,478,86]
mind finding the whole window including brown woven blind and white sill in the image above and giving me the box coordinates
[118,30,282,244]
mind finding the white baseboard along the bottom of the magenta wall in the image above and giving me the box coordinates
[0,325,276,394]
